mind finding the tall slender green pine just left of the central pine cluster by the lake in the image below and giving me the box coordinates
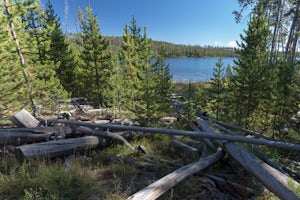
[79,7,111,106]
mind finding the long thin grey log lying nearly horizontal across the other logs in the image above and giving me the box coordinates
[49,120,300,151]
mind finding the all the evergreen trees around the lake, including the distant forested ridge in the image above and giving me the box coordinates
[0,0,300,137]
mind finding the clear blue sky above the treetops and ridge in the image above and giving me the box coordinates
[42,0,248,46]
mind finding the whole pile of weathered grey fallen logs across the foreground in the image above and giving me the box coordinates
[0,110,300,200]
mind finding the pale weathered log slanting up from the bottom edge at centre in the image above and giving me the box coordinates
[127,151,224,200]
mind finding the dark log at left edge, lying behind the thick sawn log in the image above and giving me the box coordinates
[0,132,51,146]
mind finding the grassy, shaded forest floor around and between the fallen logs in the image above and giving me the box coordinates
[0,83,300,200]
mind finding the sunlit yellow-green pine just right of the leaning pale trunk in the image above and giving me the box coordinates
[24,0,67,104]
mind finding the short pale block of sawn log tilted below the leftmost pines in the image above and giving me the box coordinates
[10,109,40,128]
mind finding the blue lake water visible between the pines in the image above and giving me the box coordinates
[166,58,234,82]
